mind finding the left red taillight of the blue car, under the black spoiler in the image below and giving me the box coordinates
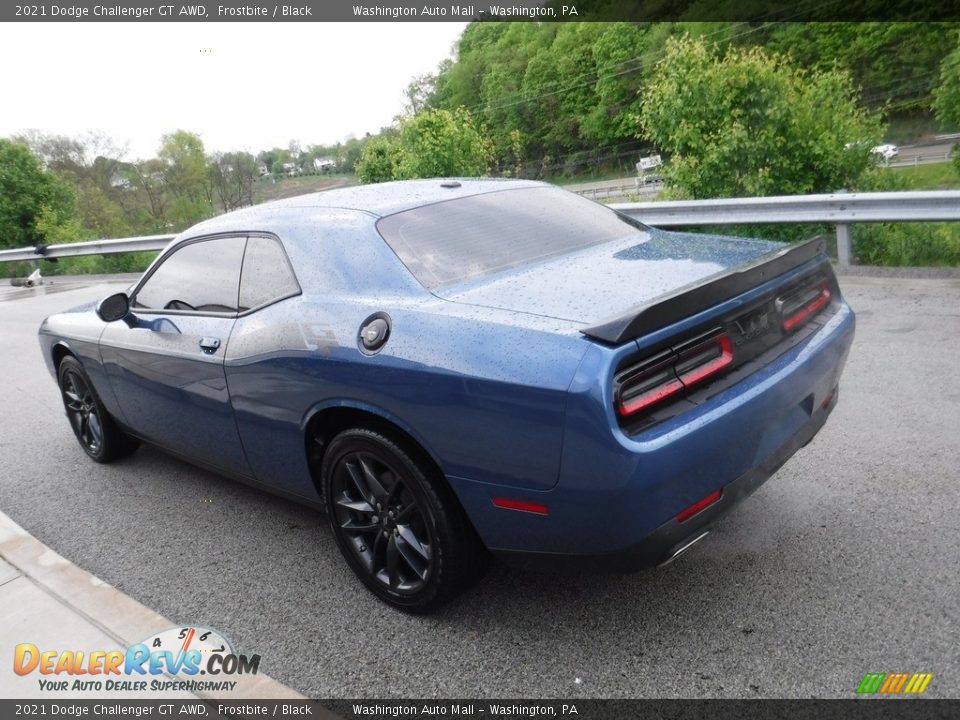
[617,331,733,417]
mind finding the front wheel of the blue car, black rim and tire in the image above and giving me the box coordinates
[57,355,140,463]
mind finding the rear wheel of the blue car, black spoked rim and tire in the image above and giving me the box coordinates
[321,428,487,613]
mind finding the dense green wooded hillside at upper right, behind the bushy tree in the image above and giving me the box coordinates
[422,21,956,183]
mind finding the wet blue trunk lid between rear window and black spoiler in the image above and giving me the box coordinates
[433,229,783,323]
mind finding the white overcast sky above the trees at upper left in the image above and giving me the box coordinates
[0,22,466,160]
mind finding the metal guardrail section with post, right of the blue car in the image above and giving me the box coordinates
[610,190,960,265]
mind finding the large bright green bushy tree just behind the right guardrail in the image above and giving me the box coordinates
[639,39,882,198]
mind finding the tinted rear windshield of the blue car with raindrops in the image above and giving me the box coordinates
[377,187,644,288]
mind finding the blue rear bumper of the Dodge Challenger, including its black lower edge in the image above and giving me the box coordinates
[451,303,855,569]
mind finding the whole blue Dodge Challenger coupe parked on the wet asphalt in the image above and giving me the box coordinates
[40,180,854,612]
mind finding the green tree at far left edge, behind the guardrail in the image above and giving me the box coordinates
[0,138,77,247]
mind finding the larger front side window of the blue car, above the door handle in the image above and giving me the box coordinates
[133,237,246,312]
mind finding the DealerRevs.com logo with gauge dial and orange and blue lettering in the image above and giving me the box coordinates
[13,626,260,692]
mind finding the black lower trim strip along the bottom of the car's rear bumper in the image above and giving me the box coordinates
[492,388,839,572]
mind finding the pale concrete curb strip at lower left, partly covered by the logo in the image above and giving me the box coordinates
[0,512,308,704]
